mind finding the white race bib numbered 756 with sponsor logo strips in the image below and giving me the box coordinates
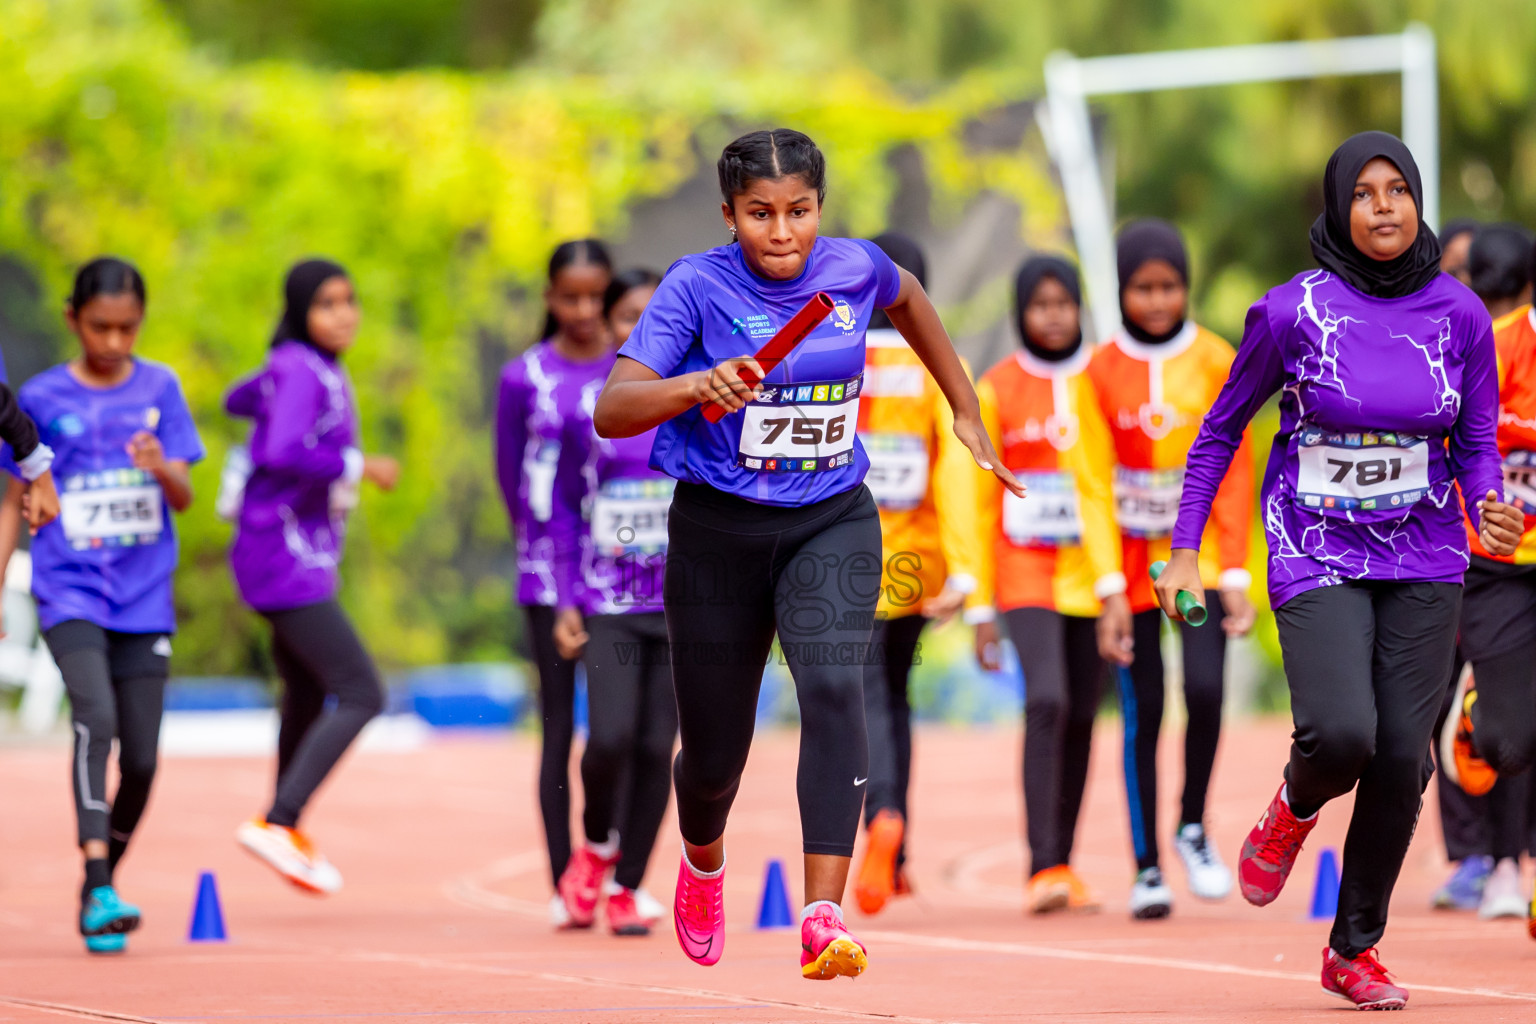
[736,375,863,473]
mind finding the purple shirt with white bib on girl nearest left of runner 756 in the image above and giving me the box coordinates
[564,385,663,616]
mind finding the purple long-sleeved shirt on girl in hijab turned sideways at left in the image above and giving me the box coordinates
[224,341,362,611]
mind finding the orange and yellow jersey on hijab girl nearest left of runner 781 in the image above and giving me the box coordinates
[1087,321,1253,611]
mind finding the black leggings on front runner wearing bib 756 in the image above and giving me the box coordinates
[665,484,880,857]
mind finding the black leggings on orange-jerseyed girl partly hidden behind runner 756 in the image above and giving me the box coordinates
[863,616,928,864]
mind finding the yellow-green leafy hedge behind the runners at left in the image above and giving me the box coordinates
[0,0,1057,672]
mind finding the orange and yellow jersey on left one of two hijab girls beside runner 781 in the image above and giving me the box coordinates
[977,345,1126,616]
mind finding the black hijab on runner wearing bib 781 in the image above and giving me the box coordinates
[1312,132,1441,299]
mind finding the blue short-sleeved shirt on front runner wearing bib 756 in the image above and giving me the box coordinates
[619,238,902,507]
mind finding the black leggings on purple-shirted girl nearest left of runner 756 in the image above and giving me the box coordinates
[581,611,677,889]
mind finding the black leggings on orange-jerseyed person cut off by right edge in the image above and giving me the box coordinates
[1458,557,1536,858]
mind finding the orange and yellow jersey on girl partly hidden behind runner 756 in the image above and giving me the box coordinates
[859,329,983,619]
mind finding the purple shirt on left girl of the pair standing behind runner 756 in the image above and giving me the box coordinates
[495,342,614,606]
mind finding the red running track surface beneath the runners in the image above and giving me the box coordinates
[0,718,1536,1024]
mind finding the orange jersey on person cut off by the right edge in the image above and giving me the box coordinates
[1465,306,1536,565]
